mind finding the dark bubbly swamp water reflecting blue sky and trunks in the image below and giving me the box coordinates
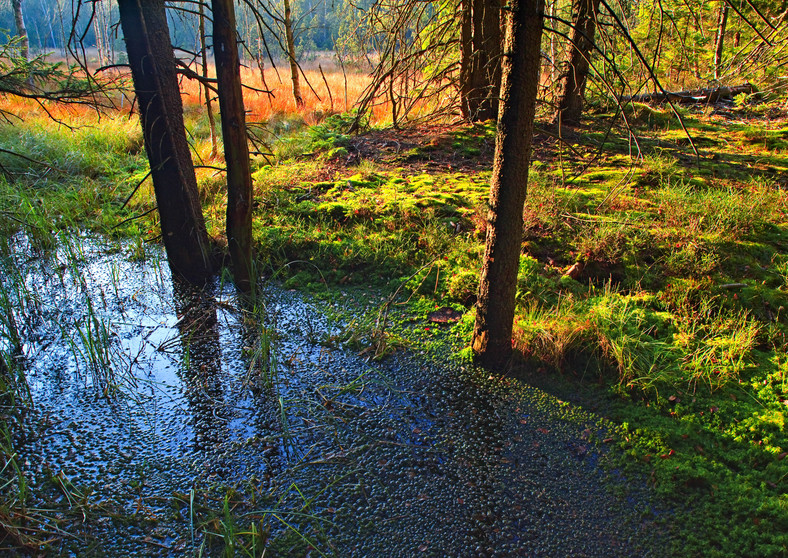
[4,236,668,557]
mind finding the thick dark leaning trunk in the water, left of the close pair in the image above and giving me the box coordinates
[118,0,212,284]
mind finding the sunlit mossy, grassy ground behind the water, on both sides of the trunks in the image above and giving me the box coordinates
[0,96,788,556]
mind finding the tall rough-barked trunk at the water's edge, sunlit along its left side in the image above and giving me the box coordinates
[473,0,544,368]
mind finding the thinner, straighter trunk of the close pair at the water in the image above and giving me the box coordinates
[211,0,254,292]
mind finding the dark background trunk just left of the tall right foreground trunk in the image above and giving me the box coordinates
[460,0,502,122]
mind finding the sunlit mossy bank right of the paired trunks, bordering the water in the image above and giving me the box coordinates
[249,107,788,556]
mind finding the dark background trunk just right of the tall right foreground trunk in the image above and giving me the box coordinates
[556,0,599,125]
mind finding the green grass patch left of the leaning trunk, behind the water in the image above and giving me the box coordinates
[0,112,153,241]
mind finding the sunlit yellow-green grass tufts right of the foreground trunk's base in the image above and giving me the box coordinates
[515,284,762,391]
